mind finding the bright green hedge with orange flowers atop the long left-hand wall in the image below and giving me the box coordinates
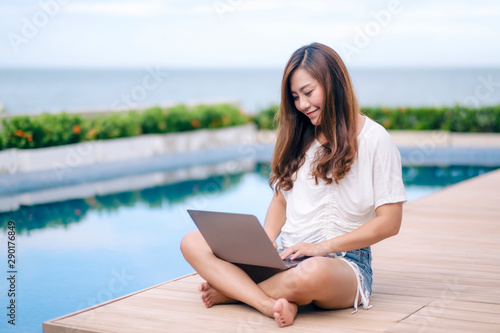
[0,104,251,150]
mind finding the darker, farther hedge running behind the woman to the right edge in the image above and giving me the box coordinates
[254,105,500,133]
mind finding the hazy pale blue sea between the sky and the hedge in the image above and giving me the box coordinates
[0,67,500,114]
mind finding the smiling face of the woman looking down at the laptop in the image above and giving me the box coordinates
[290,68,325,126]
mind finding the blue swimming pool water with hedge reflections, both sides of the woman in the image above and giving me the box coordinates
[0,164,495,332]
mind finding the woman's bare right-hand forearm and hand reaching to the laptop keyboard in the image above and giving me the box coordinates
[281,202,403,259]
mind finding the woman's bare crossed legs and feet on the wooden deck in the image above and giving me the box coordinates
[181,231,357,327]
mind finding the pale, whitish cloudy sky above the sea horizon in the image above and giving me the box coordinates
[0,0,500,68]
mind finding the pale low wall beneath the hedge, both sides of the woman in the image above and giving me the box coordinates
[0,124,500,175]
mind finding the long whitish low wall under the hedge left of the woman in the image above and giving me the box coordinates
[0,123,257,175]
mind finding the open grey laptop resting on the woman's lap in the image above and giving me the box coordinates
[187,209,308,283]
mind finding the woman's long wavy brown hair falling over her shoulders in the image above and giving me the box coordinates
[269,43,360,191]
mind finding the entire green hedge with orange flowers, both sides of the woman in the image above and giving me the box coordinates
[0,104,500,150]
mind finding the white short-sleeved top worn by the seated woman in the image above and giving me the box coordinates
[281,117,406,247]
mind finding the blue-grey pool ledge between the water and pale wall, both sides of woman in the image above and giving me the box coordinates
[0,145,500,212]
